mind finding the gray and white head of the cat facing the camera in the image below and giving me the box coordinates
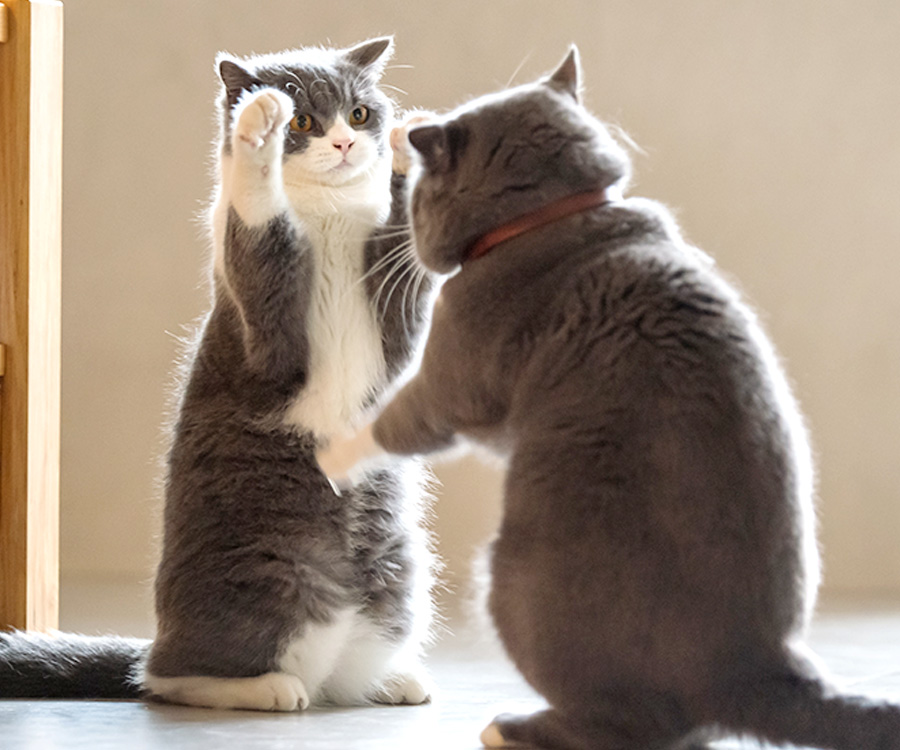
[217,37,393,185]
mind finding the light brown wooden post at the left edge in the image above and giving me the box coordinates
[0,0,63,630]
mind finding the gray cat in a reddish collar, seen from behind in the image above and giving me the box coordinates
[319,50,900,750]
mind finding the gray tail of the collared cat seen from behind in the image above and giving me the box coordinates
[717,672,900,750]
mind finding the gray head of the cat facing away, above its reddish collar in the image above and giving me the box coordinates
[409,47,631,273]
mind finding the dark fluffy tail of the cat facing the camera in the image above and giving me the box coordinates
[0,631,151,700]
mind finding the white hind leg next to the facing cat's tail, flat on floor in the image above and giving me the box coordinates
[144,672,309,711]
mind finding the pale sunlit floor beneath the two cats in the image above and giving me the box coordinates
[0,603,900,750]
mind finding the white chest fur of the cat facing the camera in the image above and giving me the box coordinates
[285,214,385,439]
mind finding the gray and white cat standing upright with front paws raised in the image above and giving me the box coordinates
[0,38,433,711]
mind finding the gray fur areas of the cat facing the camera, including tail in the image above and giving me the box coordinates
[0,39,432,698]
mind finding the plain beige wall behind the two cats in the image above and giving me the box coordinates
[62,0,900,612]
